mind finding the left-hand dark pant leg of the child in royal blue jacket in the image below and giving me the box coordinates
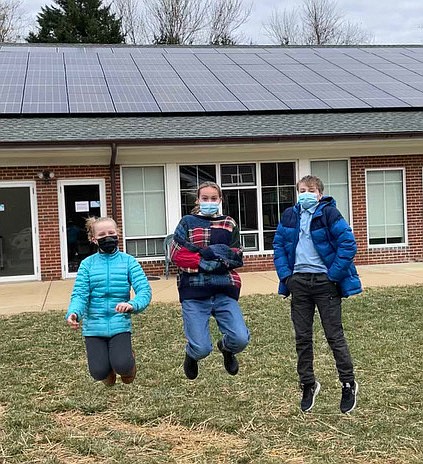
[288,273,316,385]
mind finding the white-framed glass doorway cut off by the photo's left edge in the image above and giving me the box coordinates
[0,182,40,281]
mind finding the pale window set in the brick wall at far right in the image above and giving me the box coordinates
[366,169,405,245]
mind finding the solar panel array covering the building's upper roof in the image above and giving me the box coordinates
[0,45,423,115]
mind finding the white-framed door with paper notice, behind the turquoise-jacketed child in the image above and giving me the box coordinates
[58,179,106,278]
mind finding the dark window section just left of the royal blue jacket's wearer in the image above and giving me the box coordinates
[261,163,296,250]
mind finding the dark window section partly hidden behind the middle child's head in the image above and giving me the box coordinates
[179,165,216,216]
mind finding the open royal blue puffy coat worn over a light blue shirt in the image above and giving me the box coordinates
[273,196,362,297]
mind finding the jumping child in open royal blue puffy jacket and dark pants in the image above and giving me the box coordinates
[273,176,362,413]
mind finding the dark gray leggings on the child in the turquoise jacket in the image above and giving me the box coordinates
[85,332,135,380]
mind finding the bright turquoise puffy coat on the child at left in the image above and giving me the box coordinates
[65,251,151,337]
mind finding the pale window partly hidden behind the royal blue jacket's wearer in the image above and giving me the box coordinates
[311,160,350,223]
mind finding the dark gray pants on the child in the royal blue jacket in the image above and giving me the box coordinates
[287,273,354,384]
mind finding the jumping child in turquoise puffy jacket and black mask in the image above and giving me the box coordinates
[66,217,151,386]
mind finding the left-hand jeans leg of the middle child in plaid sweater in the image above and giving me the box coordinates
[182,298,213,360]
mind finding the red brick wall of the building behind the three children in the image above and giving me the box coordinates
[0,155,423,280]
